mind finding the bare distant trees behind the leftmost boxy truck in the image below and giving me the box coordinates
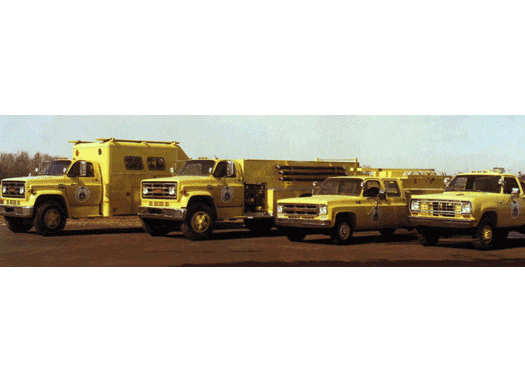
[0,151,56,180]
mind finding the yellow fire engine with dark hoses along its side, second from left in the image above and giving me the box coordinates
[139,159,360,240]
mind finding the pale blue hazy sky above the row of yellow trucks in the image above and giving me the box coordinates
[0,116,525,173]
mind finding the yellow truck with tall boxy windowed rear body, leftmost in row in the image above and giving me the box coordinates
[0,138,188,235]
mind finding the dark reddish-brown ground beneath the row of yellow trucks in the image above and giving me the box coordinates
[0,217,525,267]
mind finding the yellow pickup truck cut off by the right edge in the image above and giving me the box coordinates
[410,169,525,250]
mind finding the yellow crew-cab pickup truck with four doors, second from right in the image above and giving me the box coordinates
[275,171,445,244]
